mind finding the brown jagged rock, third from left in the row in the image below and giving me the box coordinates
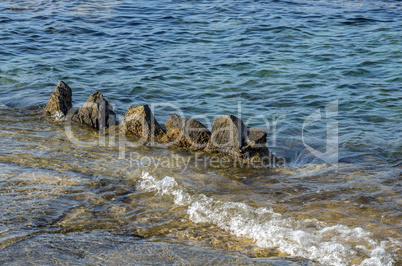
[119,104,165,140]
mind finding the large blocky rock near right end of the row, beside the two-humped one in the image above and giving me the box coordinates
[206,115,247,157]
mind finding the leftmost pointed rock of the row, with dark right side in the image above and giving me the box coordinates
[45,81,73,116]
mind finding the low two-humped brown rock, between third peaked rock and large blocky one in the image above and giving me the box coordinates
[165,114,211,150]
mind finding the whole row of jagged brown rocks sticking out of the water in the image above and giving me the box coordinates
[45,81,275,165]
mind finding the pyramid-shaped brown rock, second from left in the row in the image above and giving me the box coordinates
[72,91,116,131]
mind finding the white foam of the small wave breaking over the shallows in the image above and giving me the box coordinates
[139,172,402,265]
